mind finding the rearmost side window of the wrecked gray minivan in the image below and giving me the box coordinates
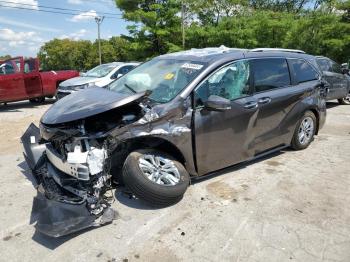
[289,59,319,83]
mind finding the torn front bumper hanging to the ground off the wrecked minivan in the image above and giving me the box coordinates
[21,124,117,237]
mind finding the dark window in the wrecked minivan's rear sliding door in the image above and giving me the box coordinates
[251,58,290,92]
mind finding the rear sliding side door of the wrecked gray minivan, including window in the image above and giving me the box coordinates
[251,57,300,155]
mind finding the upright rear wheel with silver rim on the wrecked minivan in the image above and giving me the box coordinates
[291,111,317,150]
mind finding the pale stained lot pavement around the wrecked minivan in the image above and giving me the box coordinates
[0,99,350,262]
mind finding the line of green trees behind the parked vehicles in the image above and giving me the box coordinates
[39,0,350,67]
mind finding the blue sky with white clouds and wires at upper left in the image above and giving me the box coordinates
[0,0,128,57]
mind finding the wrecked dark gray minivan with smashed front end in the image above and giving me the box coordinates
[22,48,326,236]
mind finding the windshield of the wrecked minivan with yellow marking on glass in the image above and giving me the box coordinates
[109,58,205,103]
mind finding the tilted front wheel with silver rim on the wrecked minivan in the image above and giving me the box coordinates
[123,149,190,207]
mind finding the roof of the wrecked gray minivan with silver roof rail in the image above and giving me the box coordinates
[159,46,314,63]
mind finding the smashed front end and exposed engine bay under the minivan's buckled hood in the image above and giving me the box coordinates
[21,88,190,237]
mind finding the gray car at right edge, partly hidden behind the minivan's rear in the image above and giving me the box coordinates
[316,56,350,105]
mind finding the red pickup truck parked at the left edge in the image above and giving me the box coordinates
[0,57,79,103]
